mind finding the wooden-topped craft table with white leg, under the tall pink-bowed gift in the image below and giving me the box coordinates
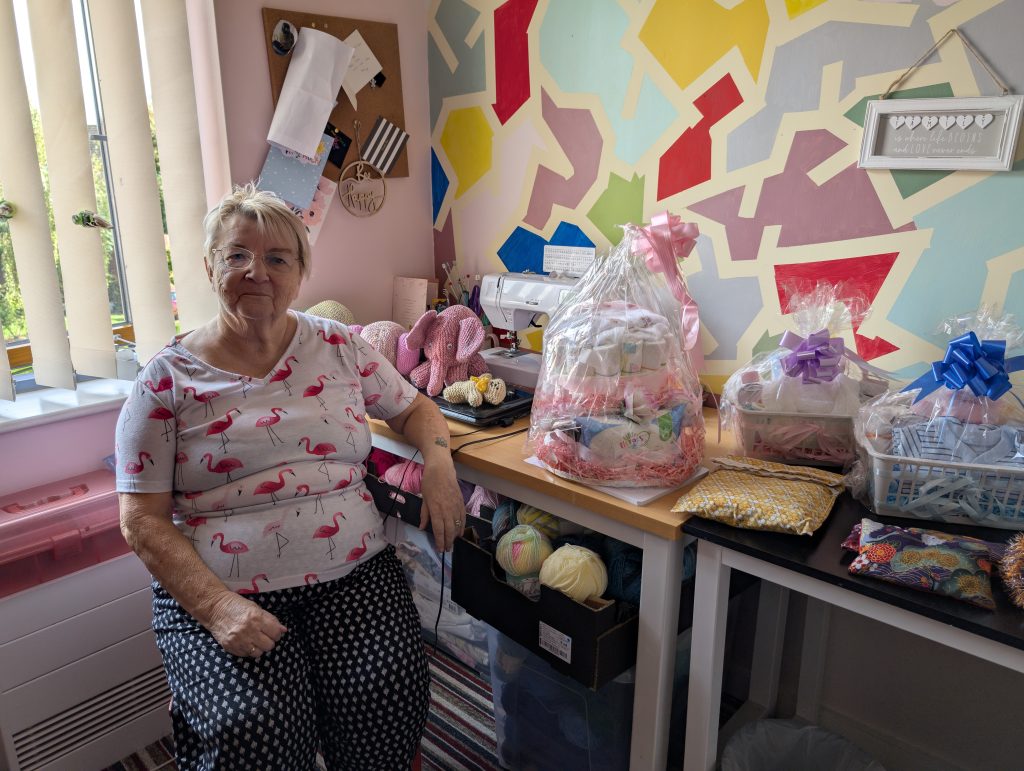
[371,418,715,771]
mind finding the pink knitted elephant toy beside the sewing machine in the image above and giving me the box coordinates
[407,305,487,396]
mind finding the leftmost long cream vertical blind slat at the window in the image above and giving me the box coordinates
[0,0,75,400]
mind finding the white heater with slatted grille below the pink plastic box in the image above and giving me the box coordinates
[0,554,170,771]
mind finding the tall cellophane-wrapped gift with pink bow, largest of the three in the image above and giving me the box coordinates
[527,213,705,487]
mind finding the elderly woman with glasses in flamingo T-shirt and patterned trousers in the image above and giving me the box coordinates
[117,185,464,771]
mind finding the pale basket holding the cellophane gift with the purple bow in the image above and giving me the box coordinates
[733,404,856,466]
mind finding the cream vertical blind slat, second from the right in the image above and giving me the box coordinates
[89,0,174,361]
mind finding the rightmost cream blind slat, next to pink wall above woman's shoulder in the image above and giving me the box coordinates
[141,0,218,331]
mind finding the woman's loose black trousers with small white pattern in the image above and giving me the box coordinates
[153,547,430,771]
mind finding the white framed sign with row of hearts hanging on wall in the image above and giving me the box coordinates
[857,95,1024,171]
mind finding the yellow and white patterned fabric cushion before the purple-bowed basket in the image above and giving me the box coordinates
[672,456,843,536]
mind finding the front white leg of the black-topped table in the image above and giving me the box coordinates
[683,541,730,771]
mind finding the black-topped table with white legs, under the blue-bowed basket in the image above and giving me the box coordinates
[683,495,1024,771]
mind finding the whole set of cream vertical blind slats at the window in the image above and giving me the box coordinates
[0,0,216,399]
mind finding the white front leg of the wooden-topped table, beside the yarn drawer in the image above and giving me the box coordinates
[630,536,684,771]
